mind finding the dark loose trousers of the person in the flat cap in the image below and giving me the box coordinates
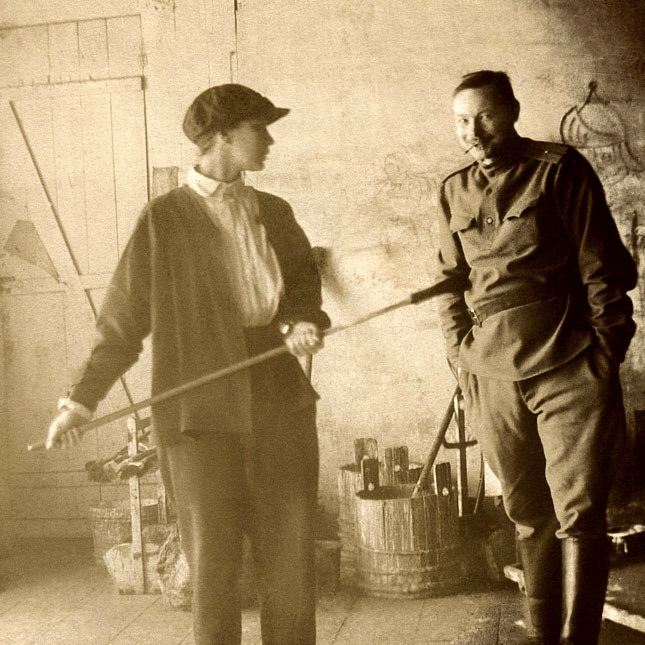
[160,405,318,645]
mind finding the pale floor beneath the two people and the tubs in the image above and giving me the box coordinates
[0,540,645,645]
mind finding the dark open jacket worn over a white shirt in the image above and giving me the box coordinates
[69,186,329,442]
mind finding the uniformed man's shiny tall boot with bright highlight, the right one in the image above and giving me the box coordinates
[560,536,609,645]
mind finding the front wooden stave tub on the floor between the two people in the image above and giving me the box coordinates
[356,485,465,598]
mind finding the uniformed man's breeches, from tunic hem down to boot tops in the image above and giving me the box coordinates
[460,348,625,540]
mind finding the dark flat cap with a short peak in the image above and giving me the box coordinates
[183,83,289,145]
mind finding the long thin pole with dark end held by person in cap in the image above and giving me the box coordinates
[27,284,446,451]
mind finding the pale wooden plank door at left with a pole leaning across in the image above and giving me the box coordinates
[0,76,149,536]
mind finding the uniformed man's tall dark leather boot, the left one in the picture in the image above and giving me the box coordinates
[517,518,562,645]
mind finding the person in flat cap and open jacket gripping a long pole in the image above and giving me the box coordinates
[46,84,330,645]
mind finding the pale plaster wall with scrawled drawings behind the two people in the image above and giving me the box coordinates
[0,0,645,532]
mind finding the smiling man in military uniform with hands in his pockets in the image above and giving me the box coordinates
[439,71,637,645]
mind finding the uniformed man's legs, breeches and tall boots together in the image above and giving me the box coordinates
[460,348,625,645]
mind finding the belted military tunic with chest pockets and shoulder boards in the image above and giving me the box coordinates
[439,137,637,380]
